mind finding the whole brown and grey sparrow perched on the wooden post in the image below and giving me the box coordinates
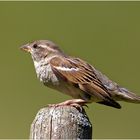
[21,40,140,109]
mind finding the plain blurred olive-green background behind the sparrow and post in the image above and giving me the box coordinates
[0,2,140,138]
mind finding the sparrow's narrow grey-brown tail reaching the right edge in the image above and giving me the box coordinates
[114,87,140,103]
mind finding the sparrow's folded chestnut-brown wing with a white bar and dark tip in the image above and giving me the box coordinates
[50,57,121,108]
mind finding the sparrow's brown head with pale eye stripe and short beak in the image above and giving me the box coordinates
[21,40,63,62]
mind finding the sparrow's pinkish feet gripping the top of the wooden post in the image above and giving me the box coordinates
[48,99,88,110]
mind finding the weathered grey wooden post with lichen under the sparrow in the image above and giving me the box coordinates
[30,106,92,140]
